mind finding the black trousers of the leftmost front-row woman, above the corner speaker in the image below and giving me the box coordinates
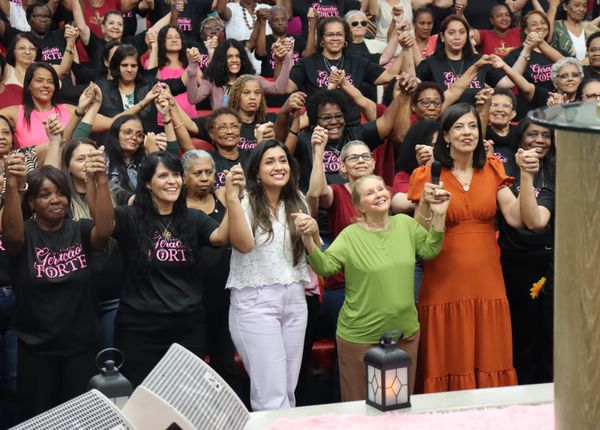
[17,341,97,420]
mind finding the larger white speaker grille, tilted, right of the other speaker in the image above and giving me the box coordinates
[142,344,250,430]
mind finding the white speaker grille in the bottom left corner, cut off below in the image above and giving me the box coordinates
[11,390,133,430]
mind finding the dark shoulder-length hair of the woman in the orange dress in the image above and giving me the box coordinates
[433,103,487,169]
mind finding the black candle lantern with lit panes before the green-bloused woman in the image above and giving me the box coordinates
[365,330,411,411]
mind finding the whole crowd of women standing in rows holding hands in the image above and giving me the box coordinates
[0,0,600,428]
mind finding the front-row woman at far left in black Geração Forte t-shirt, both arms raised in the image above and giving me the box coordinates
[2,146,114,418]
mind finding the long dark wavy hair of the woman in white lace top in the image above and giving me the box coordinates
[245,139,308,266]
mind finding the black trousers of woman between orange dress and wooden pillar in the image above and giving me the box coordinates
[501,250,554,384]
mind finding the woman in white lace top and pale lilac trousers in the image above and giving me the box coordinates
[227,140,310,411]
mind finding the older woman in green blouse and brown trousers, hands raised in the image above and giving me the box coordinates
[296,175,450,401]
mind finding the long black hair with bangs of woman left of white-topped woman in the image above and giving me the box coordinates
[133,151,194,265]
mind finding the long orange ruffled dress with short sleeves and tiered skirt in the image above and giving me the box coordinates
[408,158,517,393]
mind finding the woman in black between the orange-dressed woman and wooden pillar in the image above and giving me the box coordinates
[498,119,556,384]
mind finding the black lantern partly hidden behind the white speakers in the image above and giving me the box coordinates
[88,348,133,409]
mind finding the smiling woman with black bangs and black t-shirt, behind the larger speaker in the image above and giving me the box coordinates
[114,152,246,386]
